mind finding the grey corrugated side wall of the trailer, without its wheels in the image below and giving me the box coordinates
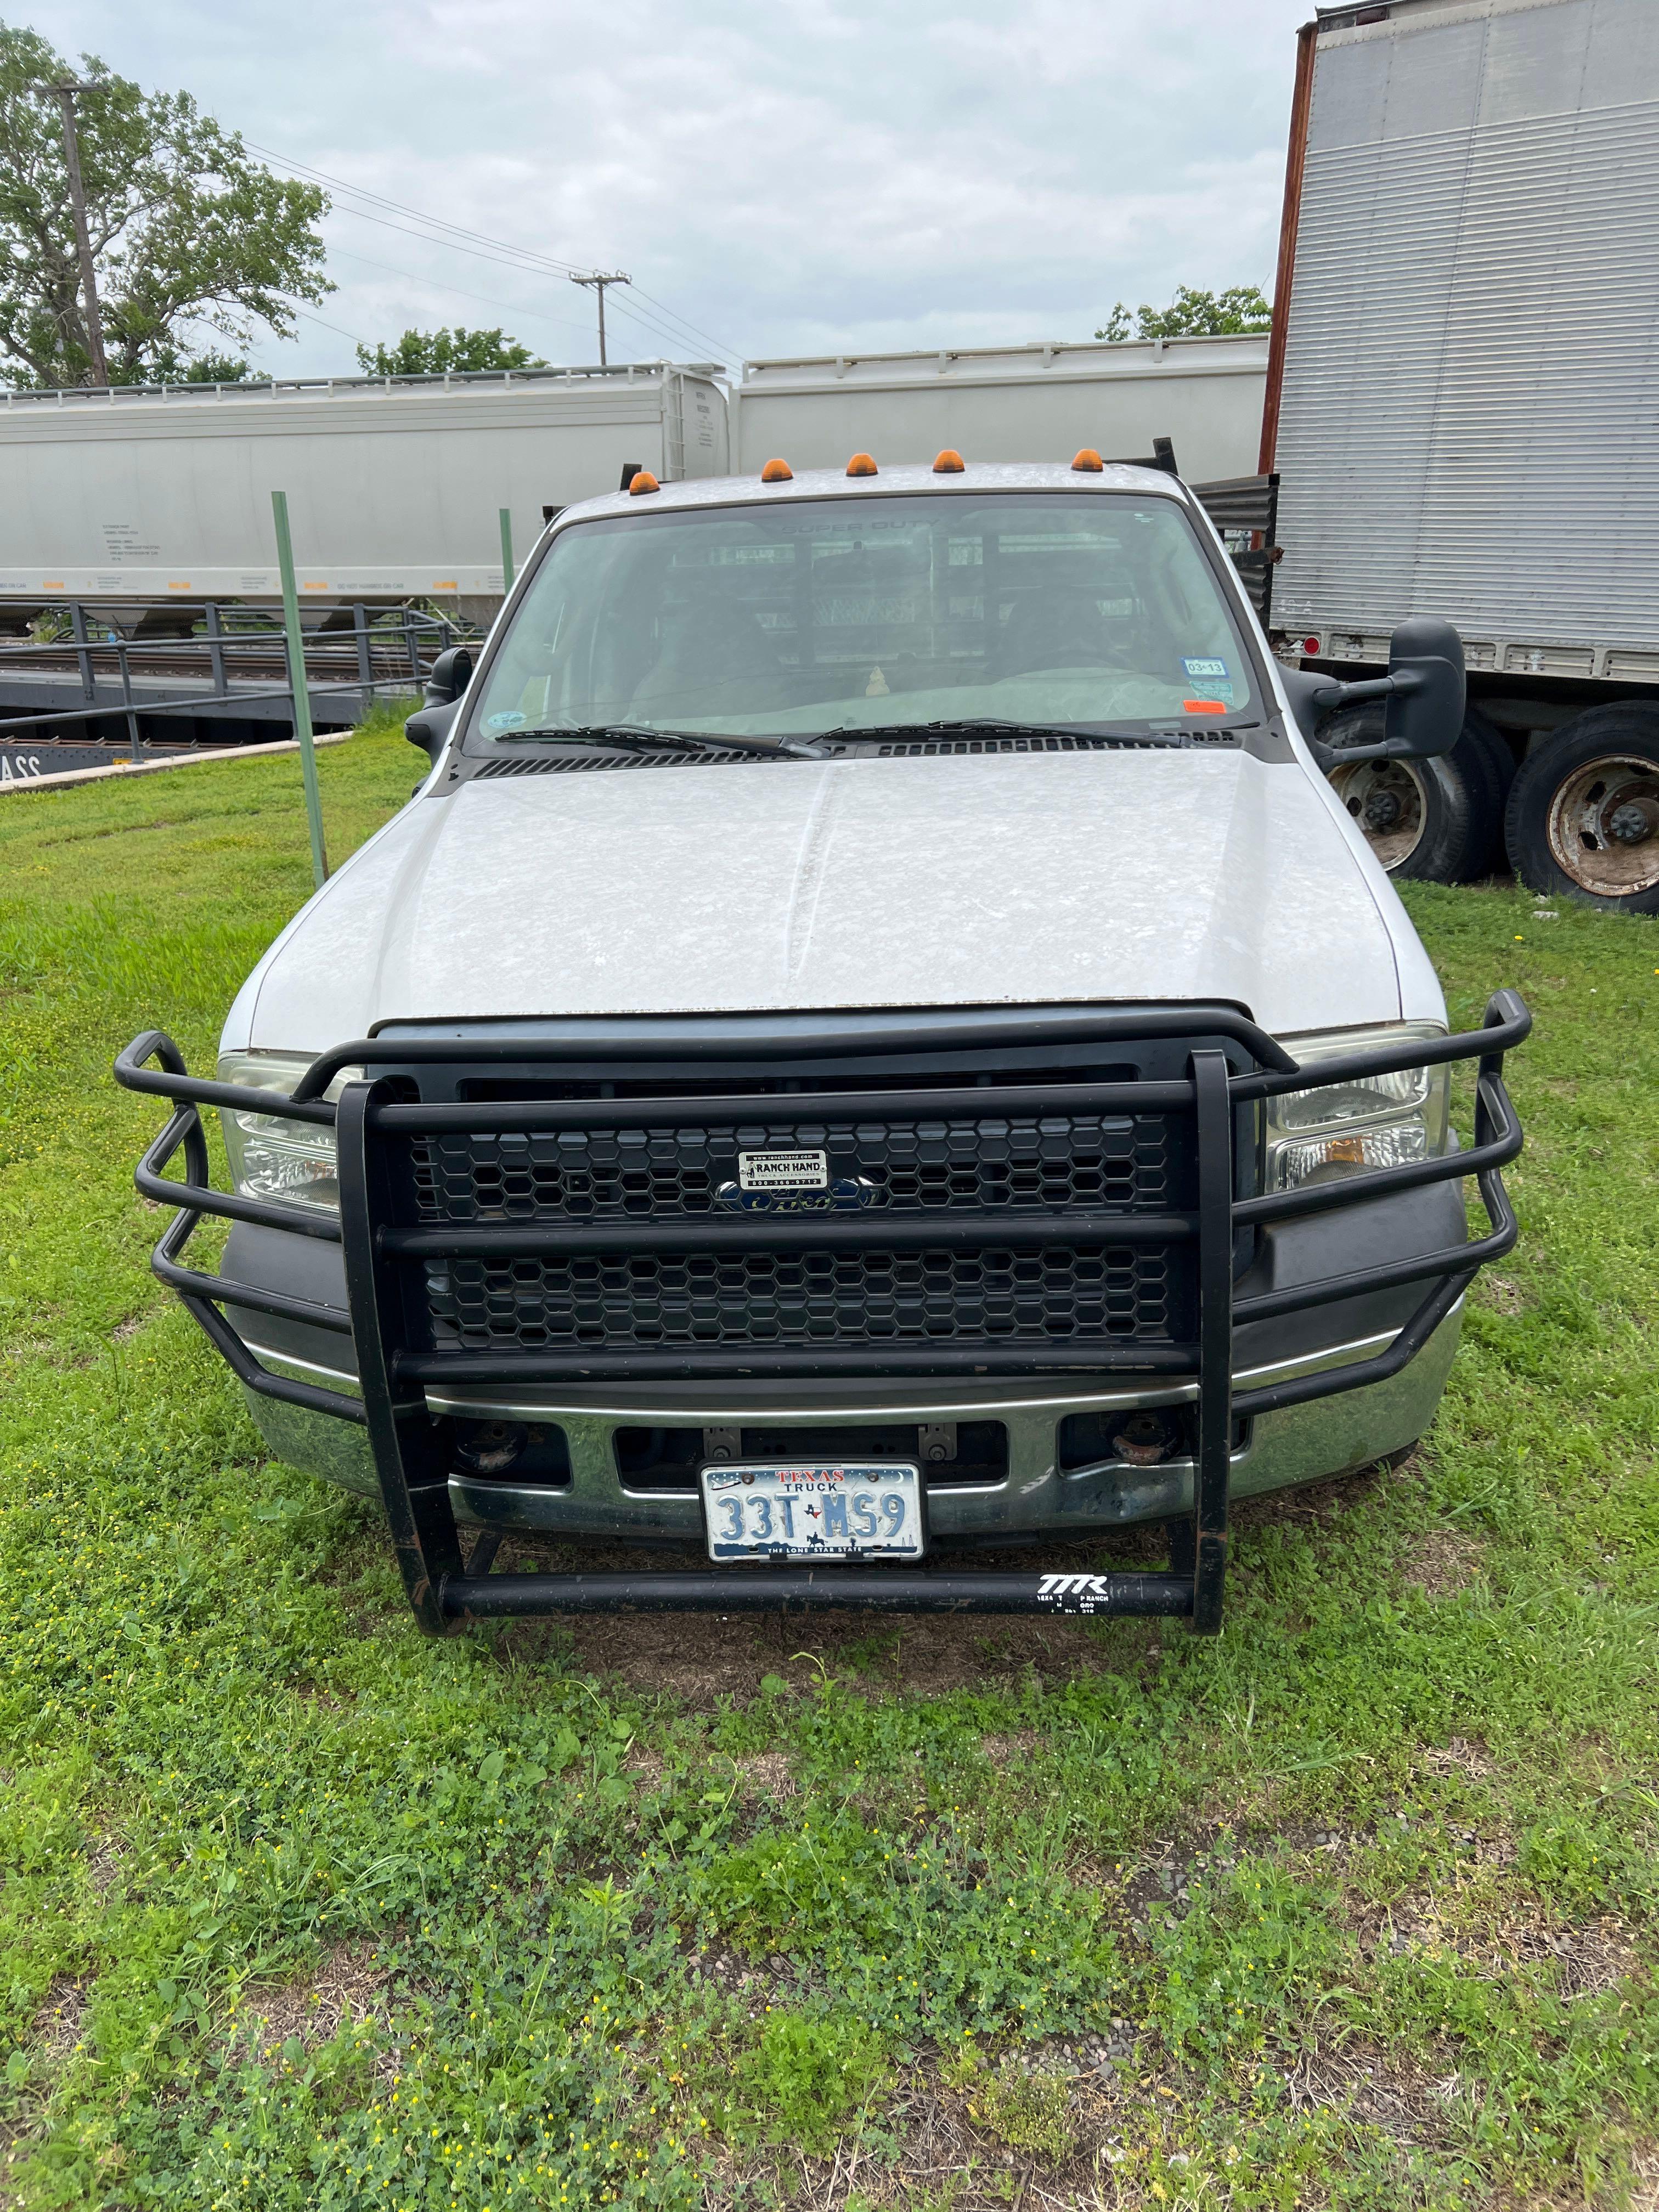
[1274,0,1659,679]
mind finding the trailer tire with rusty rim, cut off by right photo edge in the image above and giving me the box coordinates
[1504,701,1659,913]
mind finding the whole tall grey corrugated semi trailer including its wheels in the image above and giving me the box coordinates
[1261,0,1659,913]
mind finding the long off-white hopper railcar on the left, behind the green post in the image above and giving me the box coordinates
[0,363,728,613]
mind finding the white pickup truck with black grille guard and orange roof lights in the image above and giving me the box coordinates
[117,452,1528,1633]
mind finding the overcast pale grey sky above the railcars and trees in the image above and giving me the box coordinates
[36,0,1307,374]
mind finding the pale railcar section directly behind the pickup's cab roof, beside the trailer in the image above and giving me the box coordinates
[732,336,1267,482]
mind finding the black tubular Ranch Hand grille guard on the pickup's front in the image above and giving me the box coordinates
[115,991,1531,1635]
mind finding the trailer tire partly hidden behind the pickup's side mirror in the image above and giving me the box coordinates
[1318,703,1504,883]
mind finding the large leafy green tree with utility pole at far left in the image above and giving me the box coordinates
[0,22,334,385]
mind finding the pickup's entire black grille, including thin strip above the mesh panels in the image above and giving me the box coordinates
[405,1048,1197,1361]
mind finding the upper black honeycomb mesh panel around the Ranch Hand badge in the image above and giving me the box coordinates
[414,1115,1172,1223]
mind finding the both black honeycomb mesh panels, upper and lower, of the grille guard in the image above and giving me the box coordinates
[409,1093,1194,1352]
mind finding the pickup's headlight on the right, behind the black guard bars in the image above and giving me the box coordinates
[1267,1022,1449,1190]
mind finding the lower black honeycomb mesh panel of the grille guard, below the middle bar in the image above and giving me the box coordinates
[427,1245,1172,1352]
